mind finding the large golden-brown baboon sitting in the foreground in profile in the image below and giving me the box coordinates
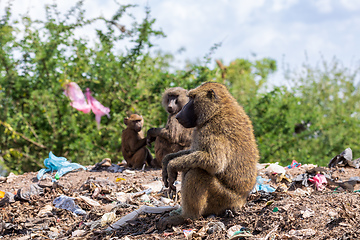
[158,82,259,229]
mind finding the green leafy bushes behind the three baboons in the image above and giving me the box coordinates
[0,1,360,173]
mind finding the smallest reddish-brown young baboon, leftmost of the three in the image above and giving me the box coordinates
[121,114,152,168]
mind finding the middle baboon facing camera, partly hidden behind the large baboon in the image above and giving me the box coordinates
[147,87,193,167]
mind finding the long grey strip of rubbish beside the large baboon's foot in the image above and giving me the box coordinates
[106,205,179,231]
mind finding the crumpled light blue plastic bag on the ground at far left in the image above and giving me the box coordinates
[37,151,86,180]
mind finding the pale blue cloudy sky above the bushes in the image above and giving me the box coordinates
[0,0,360,84]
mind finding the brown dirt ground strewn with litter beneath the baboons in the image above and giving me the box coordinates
[0,160,360,240]
